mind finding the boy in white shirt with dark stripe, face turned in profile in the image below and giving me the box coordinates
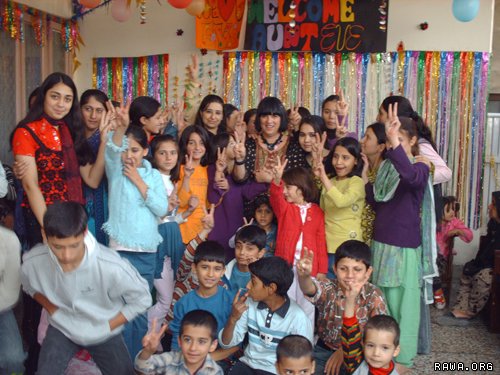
[219,257,313,375]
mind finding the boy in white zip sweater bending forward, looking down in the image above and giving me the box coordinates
[21,202,151,375]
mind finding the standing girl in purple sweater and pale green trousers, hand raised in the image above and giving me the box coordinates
[365,104,436,366]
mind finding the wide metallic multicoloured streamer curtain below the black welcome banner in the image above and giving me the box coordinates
[222,51,490,228]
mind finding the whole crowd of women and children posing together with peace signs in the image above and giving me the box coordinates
[0,73,480,374]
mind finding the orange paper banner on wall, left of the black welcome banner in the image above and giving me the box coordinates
[196,0,246,51]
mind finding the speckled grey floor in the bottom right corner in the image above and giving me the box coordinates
[412,268,500,375]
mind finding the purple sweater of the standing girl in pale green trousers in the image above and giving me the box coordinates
[365,145,429,248]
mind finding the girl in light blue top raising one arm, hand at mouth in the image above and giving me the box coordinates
[103,102,168,358]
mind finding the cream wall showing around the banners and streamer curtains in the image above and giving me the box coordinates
[74,0,494,264]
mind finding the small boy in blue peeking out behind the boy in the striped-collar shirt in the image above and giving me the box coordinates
[224,225,266,293]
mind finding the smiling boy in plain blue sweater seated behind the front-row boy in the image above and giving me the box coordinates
[169,241,234,350]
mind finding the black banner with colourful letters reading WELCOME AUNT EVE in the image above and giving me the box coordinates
[245,0,389,53]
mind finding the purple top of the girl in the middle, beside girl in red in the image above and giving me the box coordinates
[207,164,269,262]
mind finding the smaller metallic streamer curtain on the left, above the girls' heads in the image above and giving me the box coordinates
[92,55,168,105]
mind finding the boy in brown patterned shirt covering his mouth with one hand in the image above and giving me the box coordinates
[297,240,387,373]
